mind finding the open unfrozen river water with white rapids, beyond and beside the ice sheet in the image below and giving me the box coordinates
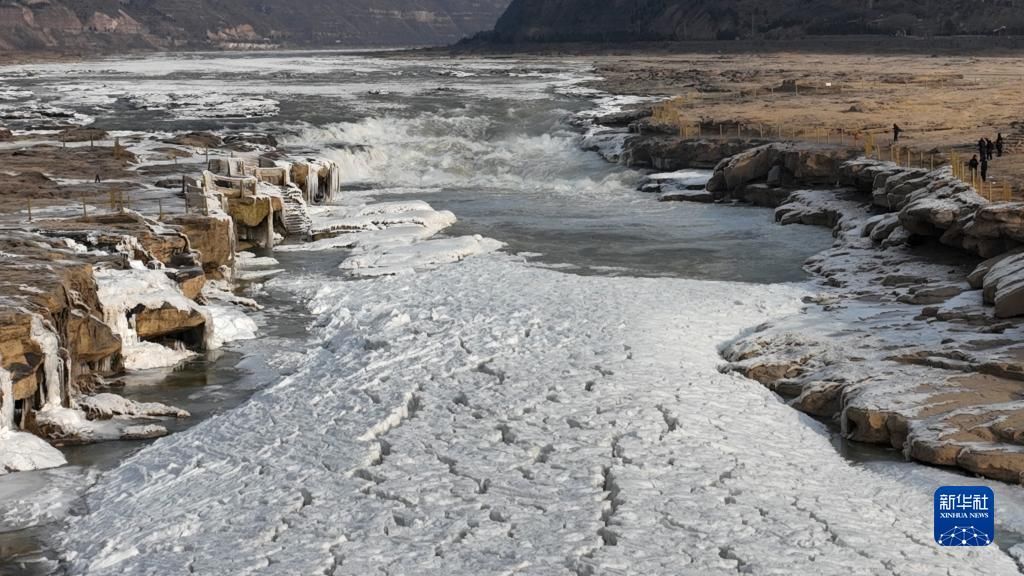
[6,52,1015,574]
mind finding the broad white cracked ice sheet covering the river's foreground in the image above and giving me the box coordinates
[65,254,1016,575]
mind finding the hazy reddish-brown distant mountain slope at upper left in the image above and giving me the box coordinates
[0,0,509,51]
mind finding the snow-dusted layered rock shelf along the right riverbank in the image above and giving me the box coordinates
[602,109,1024,483]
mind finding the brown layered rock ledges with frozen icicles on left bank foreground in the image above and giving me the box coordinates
[0,206,249,461]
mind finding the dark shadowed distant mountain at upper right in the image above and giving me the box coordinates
[483,0,1024,42]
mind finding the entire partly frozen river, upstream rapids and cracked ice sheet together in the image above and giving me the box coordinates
[0,53,1024,576]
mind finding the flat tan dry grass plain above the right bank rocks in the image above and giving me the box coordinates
[597,53,1024,186]
